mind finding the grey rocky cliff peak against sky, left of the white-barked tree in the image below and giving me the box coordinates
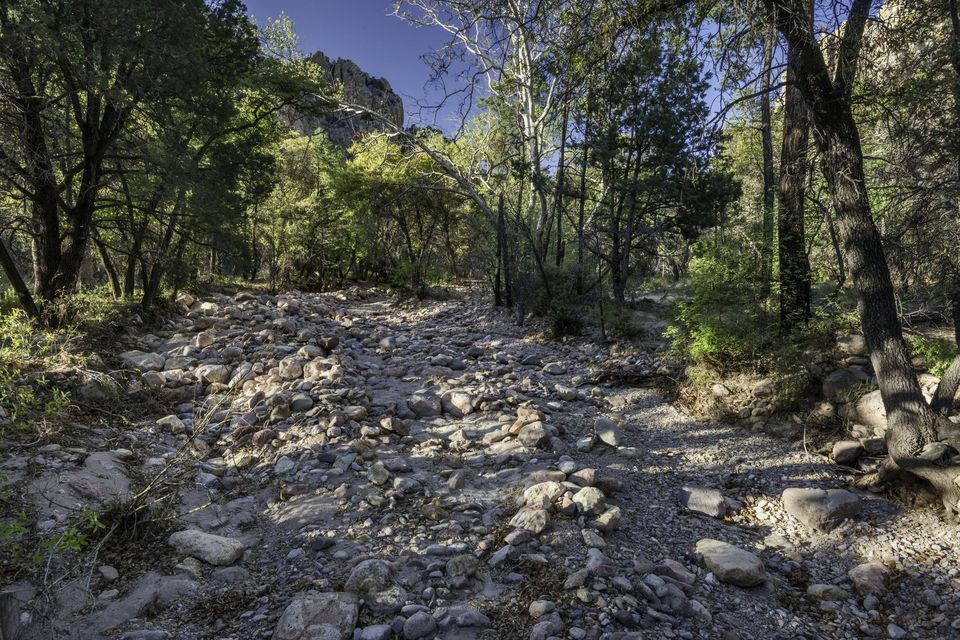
[287,51,404,147]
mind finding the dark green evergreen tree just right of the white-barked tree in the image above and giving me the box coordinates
[586,36,726,303]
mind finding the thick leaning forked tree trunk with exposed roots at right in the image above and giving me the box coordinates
[764,0,960,515]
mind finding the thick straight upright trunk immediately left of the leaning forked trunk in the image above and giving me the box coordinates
[778,21,810,333]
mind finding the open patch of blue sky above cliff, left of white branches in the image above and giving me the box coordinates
[246,0,460,128]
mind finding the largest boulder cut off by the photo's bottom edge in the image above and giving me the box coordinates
[273,592,360,640]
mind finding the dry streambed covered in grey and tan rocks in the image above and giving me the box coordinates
[0,290,960,640]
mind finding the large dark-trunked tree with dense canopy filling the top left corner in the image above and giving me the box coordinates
[0,0,216,300]
